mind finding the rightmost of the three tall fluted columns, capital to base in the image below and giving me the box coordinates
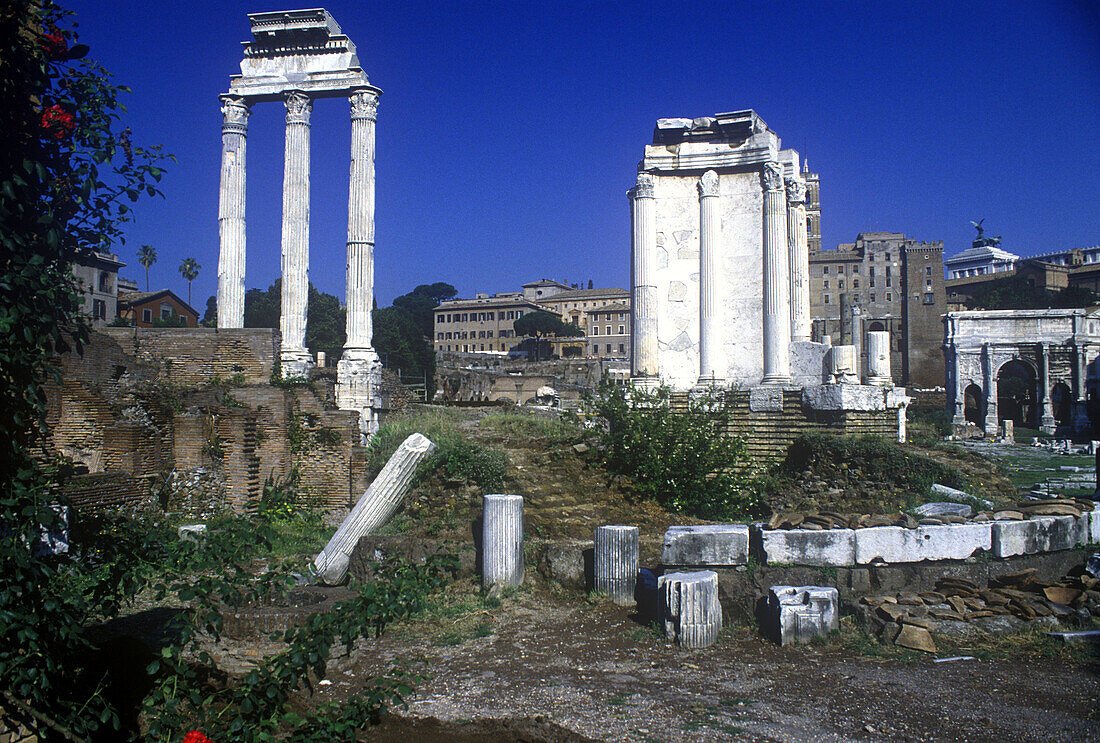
[343,90,378,360]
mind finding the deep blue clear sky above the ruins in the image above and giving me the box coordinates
[63,0,1100,309]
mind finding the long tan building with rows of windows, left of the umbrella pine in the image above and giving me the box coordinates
[432,289,542,353]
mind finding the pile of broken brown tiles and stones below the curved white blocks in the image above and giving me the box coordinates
[856,568,1100,653]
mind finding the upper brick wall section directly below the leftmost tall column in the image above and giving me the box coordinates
[103,328,279,386]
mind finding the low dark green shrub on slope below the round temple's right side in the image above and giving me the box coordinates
[780,434,965,494]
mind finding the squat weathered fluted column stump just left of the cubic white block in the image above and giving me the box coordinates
[657,570,722,648]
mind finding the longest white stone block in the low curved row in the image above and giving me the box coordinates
[856,523,992,565]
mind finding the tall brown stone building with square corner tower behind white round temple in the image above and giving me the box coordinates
[810,232,946,387]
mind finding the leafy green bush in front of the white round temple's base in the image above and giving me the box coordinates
[590,384,768,518]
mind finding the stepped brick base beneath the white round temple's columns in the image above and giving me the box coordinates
[726,390,898,462]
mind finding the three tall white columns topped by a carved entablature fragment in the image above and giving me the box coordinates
[218,9,382,434]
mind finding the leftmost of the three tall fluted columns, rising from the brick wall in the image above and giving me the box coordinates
[218,96,249,328]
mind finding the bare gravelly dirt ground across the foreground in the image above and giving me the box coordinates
[301,591,1100,743]
